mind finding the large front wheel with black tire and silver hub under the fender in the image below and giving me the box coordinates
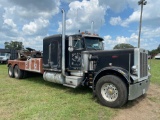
[96,75,127,108]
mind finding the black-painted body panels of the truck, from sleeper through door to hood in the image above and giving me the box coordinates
[43,34,134,76]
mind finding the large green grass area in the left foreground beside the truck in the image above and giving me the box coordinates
[0,65,117,120]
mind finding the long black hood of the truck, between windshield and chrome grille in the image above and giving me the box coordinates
[84,49,134,71]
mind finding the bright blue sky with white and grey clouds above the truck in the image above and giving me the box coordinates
[0,0,160,50]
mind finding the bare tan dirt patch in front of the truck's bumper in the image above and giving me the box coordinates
[113,84,160,120]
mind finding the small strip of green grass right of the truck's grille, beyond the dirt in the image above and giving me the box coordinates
[149,59,160,85]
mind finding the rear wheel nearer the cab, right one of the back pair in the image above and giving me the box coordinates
[14,65,24,79]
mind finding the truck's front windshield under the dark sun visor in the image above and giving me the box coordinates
[85,37,103,50]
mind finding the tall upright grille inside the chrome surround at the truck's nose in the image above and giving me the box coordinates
[140,53,148,78]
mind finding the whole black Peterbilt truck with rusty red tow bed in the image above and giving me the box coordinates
[8,10,150,108]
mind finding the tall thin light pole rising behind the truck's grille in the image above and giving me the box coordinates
[138,0,147,48]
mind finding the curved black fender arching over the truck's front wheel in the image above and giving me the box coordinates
[93,66,131,90]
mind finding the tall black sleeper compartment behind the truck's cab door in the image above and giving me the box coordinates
[43,34,68,71]
